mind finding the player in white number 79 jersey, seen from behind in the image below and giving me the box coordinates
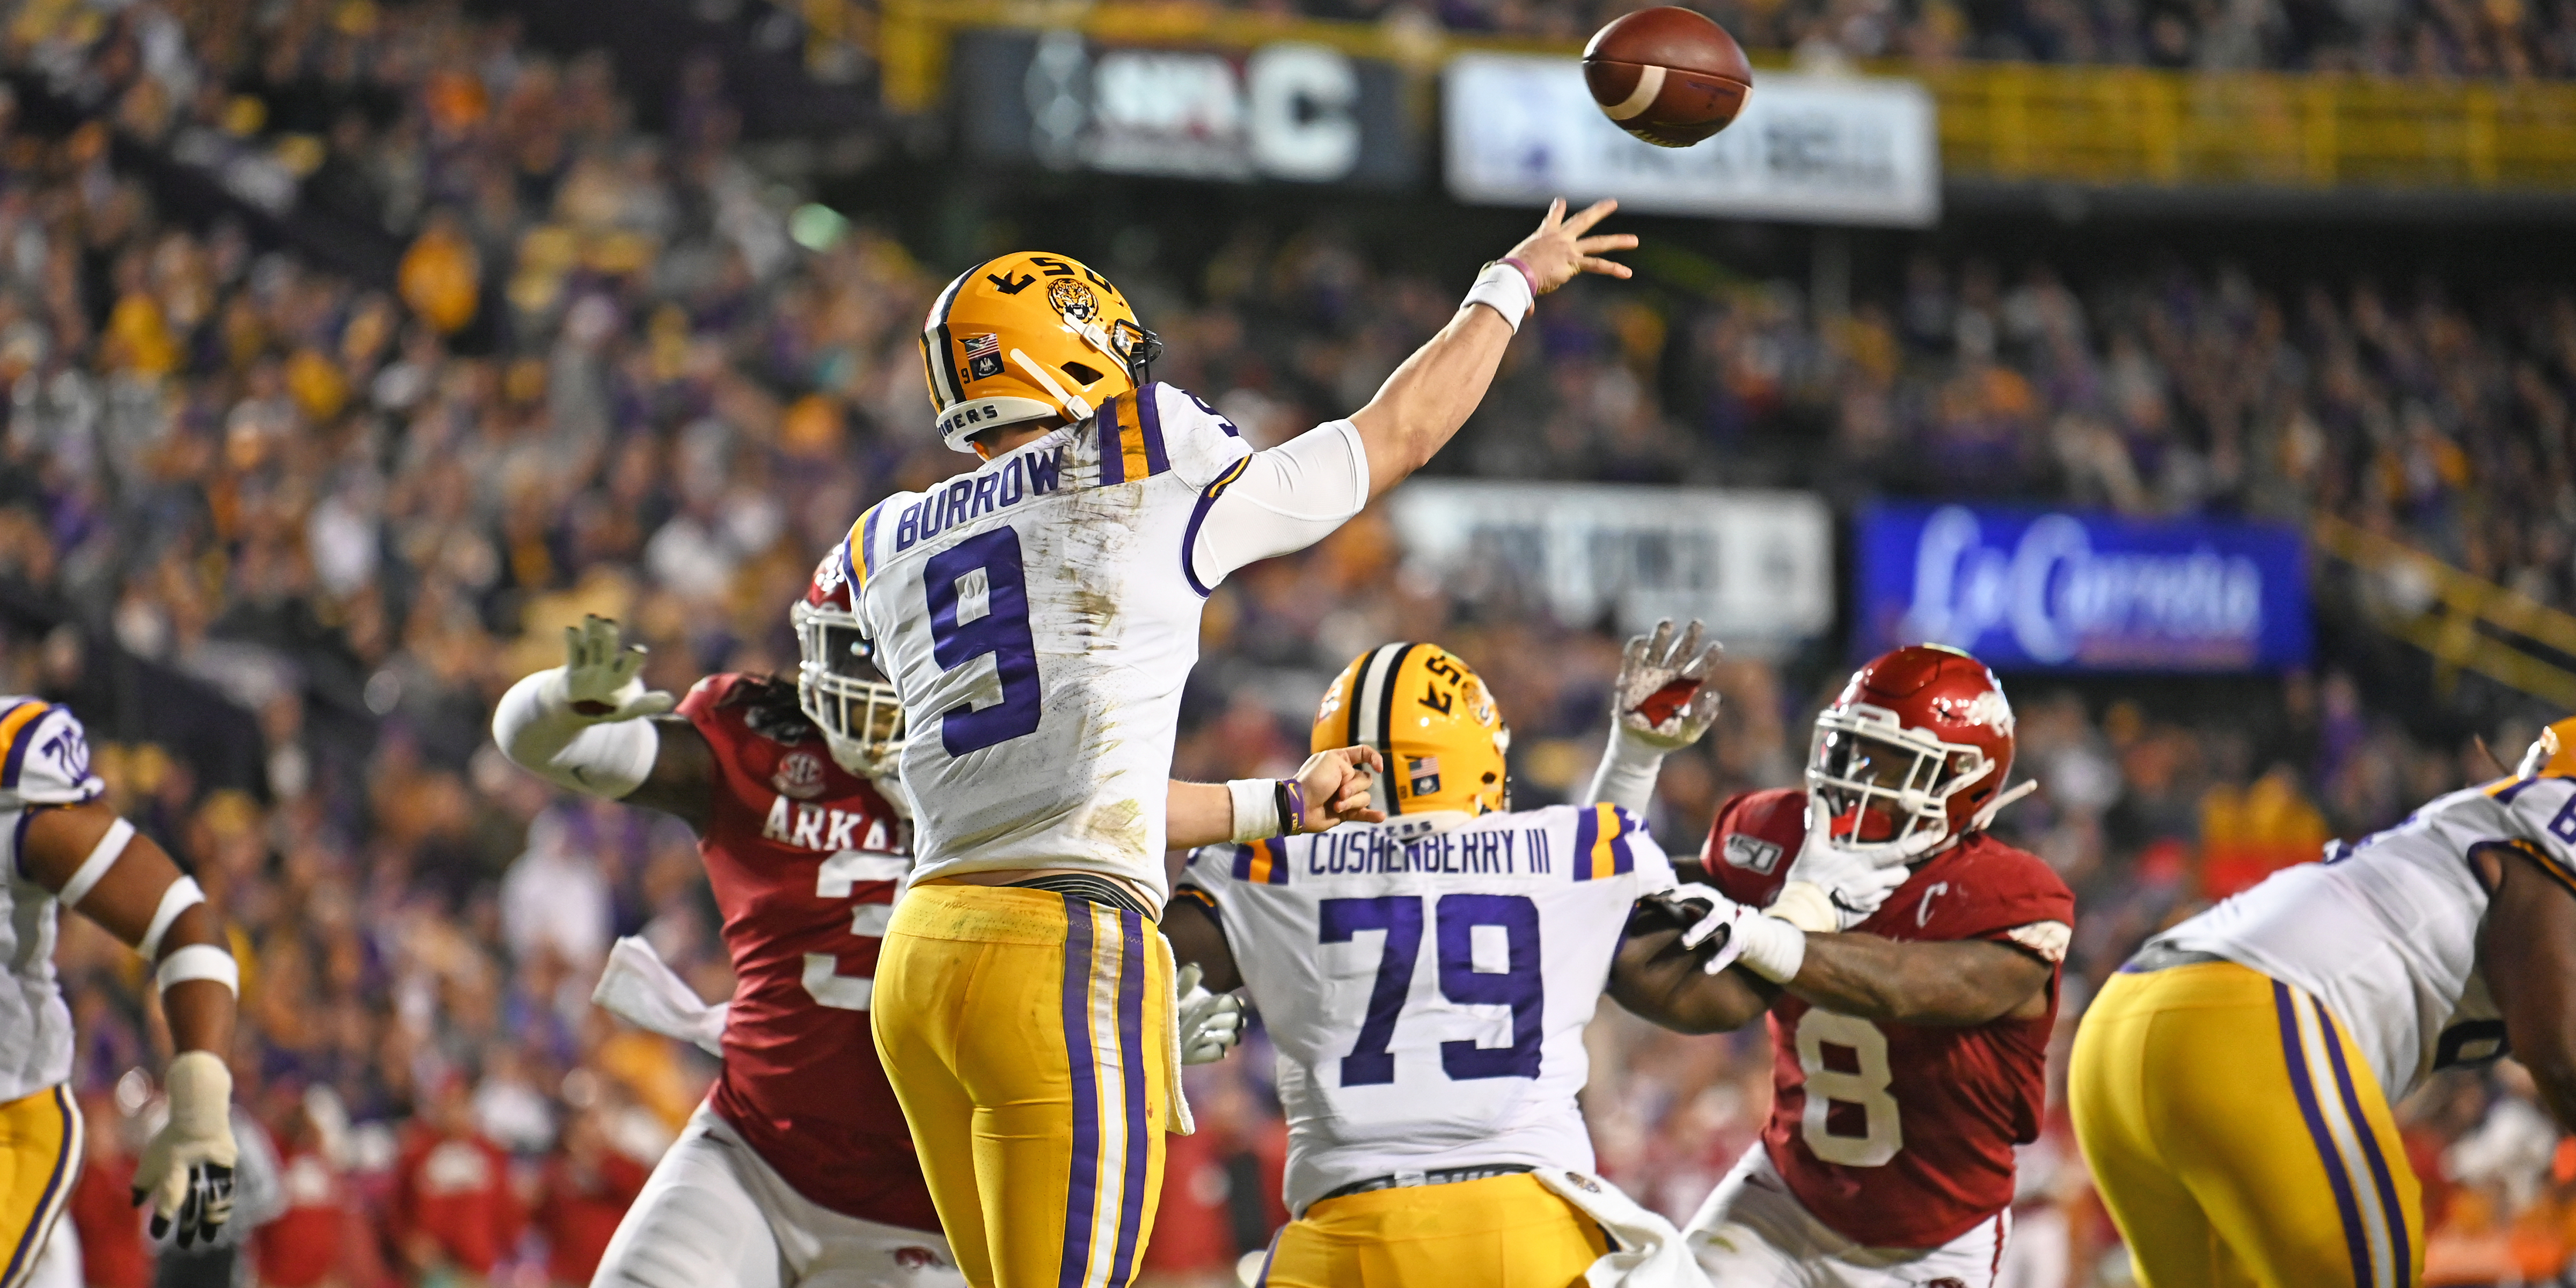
[1169,628,1716,1288]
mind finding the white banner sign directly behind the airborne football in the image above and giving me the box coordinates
[1443,54,1940,226]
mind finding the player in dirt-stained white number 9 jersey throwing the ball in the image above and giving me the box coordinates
[843,201,1636,1288]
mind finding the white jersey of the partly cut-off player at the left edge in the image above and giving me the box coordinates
[0,698,106,1102]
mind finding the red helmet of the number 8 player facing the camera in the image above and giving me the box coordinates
[1806,644,2030,863]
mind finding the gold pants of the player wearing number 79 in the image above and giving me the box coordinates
[1260,1175,1610,1288]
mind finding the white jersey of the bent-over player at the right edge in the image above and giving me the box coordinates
[2156,773,2576,1102]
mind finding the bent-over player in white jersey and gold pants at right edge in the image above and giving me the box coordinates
[2068,721,2576,1288]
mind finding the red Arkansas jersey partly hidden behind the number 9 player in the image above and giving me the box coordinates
[680,675,940,1231]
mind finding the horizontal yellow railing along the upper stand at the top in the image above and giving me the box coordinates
[876,0,2576,193]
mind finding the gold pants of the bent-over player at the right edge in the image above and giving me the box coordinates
[2068,961,2424,1288]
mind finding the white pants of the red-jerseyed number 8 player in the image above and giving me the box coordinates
[1682,1141,2012,1288]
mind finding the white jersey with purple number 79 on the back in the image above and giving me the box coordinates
[1180,804,1672,1211]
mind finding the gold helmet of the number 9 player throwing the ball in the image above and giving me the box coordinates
[922,250,1162,451]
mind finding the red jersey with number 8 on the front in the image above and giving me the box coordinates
[1700,788,2076,1247]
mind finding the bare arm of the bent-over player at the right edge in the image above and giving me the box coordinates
[2468,845,2576,1126]
